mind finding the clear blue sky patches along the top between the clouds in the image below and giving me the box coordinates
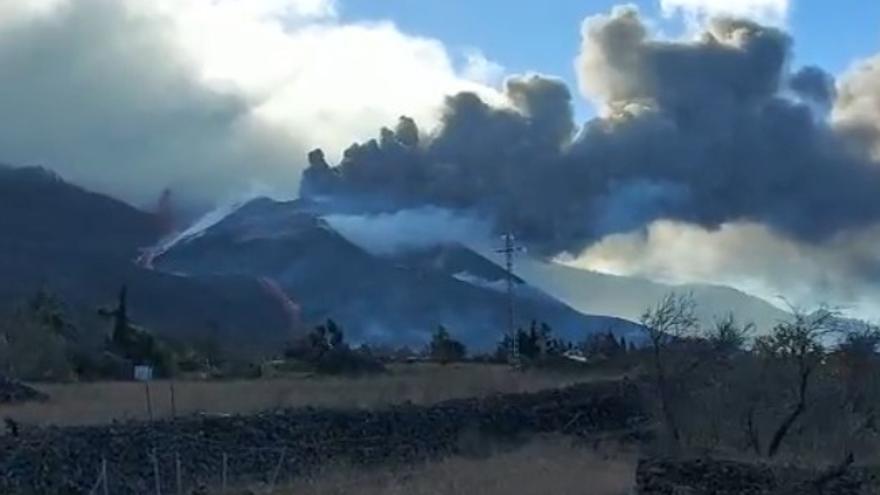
[339,0,880,118]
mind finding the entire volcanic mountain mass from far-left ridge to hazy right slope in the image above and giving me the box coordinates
[0,167,785,354]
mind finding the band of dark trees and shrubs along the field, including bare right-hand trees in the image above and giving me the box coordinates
[6,287,880,470]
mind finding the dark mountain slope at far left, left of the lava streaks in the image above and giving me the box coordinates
[0,167,289,351]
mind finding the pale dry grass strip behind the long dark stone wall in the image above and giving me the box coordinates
[0,363,612,425]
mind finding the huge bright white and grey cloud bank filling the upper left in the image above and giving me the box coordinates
[0,0,497,208]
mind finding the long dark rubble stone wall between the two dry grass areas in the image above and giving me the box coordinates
[0,382,647,495]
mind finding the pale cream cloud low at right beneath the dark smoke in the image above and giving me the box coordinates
[563,220,880,319]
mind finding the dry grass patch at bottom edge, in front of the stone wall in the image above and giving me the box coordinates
[241,437,637,495]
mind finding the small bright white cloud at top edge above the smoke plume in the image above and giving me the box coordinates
[660,0,791,25]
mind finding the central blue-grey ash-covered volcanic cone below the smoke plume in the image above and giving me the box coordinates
[154,198,638,349]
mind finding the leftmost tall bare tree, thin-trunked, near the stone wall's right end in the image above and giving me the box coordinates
[641,292,698,448]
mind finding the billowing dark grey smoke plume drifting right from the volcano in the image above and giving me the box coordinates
[301,8,880,254]
